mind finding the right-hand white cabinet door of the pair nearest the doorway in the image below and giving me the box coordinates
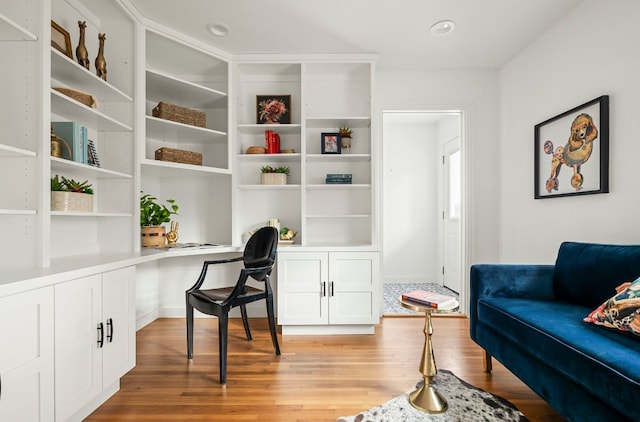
[329,252,380,325]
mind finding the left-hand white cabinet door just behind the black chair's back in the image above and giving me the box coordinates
[277,252,329,325]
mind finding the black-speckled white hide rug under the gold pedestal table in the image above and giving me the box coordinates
[337,369,528,422]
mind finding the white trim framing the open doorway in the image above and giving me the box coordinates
[372,104,472,315]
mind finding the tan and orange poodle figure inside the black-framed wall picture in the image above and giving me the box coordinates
[543,113,598,193]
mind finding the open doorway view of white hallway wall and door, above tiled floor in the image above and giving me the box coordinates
[382,110,466,310]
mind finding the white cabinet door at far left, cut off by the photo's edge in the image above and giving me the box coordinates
[0,287,54,422]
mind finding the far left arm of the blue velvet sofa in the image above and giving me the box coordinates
[469,264,554,338]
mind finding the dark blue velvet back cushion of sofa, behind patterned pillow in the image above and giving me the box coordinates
[553,242,640,308]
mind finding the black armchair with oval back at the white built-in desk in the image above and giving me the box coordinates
[186,227,280,384]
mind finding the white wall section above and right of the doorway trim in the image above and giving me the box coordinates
[375,70,499,279]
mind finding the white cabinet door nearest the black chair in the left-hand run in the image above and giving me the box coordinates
[102,267,136,388]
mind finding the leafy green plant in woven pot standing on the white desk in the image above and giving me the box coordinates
[140,192,178,247]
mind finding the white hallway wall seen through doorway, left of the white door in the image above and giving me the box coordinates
[382,113,440,283]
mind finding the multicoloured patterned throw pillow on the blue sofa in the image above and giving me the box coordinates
[583,278,640,336]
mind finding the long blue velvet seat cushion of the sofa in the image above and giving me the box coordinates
[478,298,640,420]
